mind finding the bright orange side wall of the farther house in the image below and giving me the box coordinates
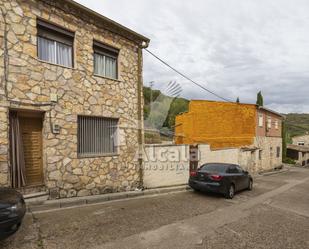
[175,100,256,149]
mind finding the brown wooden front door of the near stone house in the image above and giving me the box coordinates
[19,117,43,186]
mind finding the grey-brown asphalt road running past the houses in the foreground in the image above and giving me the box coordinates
[0,165,309,249]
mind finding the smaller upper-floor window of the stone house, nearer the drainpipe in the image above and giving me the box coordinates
[93,41,119,79]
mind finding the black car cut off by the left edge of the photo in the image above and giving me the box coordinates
[0,188,26,240]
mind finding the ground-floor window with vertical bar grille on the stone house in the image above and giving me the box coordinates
[78,116,118,156]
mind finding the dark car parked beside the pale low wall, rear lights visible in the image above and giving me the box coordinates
[189,163,253,199]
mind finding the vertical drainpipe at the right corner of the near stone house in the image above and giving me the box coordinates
[137,42,149,189]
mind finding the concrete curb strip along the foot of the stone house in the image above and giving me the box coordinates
[25,185,191,212]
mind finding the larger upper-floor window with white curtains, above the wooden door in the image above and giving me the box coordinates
[37,20,74,67]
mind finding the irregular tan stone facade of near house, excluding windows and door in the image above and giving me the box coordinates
[0,0,147,198]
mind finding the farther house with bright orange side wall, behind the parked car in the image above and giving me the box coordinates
[175,100,283,172]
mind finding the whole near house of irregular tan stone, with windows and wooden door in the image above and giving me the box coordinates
[0,0,149,198]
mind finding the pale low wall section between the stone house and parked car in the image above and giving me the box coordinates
[143,144,189,188]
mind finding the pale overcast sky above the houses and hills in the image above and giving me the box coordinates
[77,0,309,113]
